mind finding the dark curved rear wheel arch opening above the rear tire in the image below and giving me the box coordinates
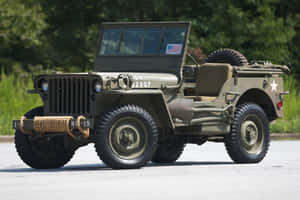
[236,88,278,121]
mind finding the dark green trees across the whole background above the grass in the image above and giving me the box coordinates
[0,0,300,73]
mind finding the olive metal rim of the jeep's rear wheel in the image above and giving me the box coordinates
[241,115,264,154]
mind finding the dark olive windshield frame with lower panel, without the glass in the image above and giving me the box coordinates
[94,21,191,79]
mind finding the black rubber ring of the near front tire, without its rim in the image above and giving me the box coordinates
[95,105,158,169]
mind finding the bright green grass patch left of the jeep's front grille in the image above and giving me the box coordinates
[0,73,42,135]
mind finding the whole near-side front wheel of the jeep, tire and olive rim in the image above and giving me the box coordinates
[95,105,158,169]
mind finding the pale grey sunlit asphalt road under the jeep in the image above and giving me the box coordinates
[0,141,300,200]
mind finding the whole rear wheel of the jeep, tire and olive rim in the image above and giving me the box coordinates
[224,104,270,163]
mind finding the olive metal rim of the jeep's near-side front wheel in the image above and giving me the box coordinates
[109,117,148,160]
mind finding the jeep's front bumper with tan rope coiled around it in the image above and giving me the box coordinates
[13,116,94,139]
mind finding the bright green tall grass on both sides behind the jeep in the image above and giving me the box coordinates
[0,73,300,135]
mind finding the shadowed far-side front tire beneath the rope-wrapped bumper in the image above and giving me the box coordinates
[15,107,75,169]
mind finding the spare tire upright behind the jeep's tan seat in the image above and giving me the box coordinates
[206,48,248,66]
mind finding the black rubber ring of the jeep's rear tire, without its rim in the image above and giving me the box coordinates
[224,103,270,163]
